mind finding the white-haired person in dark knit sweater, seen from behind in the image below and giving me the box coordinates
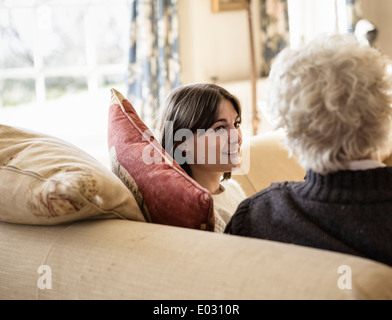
[225,35,392,265]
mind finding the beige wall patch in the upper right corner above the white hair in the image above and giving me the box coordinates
[362,0,392,57]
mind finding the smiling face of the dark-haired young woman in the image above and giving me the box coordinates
[191,99,242,173]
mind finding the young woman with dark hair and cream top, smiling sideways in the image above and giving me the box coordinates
[160,84,246,232]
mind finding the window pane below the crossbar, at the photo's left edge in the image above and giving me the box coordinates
[0,79,35,107]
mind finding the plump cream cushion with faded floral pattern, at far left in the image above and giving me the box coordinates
[0,125,145,225]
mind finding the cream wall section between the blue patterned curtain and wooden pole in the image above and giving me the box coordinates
[178,0,260,83]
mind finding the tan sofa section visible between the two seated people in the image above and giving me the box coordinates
[233,131,306,197]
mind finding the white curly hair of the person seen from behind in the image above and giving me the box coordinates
[266,34,392,174]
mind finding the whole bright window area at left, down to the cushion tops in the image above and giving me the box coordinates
[0,0,130,165]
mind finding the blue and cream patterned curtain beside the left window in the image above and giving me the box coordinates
[127,0,180,129]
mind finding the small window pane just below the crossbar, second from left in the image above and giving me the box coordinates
[45,77,87,99]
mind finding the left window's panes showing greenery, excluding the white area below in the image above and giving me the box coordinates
[0,0,129,107]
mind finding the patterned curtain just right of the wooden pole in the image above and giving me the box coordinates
[260,0,290,77]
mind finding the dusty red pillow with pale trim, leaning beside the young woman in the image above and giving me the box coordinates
[108,89,214,231]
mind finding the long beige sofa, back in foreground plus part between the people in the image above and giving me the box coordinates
[0,133,392,300]
